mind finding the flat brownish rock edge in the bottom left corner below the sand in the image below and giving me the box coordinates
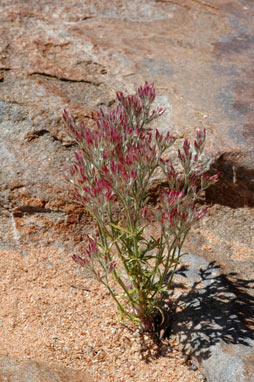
[0,357,91,382]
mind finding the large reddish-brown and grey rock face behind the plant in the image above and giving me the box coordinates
[0,0,254,277]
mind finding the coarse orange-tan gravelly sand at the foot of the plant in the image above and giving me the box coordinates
[0,247,204,382]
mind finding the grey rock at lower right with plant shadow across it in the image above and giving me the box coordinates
[172,254,254,382]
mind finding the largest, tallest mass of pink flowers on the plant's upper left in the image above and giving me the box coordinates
[63,82,174,218]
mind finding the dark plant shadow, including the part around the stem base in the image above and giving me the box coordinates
[140,255,254,363]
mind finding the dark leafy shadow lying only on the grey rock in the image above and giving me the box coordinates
[172,262,254,361]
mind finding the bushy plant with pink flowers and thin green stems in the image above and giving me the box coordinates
[63,82,217,331]
